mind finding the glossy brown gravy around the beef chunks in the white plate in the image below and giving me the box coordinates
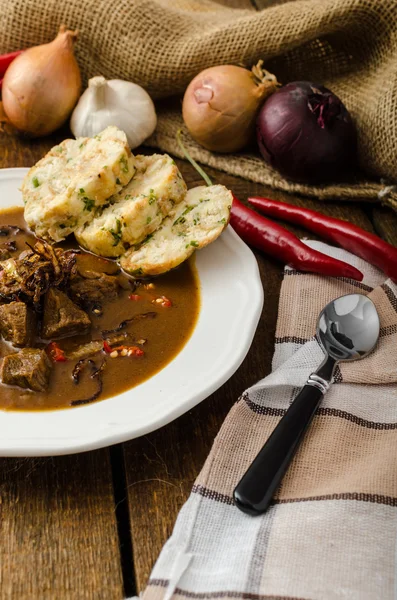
[0,208,200,410]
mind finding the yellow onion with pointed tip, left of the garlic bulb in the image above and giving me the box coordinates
[2,25,81,137]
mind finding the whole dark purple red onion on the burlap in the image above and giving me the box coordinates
[257,81,357,183]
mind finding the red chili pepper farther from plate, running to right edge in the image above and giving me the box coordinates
[248,197,397,281]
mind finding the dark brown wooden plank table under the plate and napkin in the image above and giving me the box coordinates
[0,123,397,600]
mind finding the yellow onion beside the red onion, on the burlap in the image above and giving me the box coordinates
[182,60,279,152]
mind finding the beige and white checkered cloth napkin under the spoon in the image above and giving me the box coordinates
[143,242,397,600]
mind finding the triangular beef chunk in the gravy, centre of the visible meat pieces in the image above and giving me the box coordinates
[42,288,91,339]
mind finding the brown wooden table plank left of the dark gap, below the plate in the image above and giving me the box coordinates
[0,130,124,600]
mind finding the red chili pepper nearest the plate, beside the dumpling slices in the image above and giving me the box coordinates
[230,196,363,281]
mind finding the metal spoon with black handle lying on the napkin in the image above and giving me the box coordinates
[233,294,379,515]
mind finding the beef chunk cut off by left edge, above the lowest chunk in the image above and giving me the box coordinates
[0,302,36,346]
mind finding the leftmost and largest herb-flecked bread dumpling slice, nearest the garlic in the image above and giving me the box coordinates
[21,127,135,242]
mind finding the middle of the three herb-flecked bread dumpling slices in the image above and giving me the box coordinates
[75,154,187,257]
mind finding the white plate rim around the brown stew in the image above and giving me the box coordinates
[0,169,263,456]
